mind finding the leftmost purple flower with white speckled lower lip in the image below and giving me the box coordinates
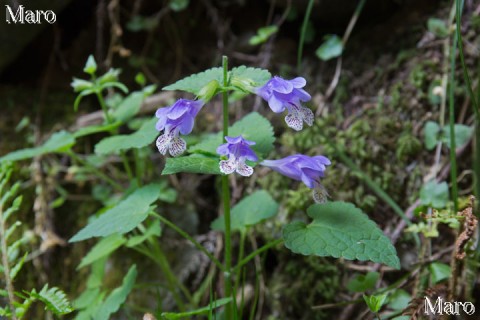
[155,99,205,157]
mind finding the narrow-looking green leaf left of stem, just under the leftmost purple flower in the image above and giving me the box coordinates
[162,155,221,174]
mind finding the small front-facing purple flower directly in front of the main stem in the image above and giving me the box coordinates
[217,136,258,177]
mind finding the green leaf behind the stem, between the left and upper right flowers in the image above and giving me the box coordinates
[188,112,275,157]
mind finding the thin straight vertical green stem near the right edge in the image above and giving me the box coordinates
[448,13,458,212]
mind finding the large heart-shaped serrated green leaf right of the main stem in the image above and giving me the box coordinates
[283,202,400,269]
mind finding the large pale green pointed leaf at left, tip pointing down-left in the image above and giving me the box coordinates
[69,184,162,242]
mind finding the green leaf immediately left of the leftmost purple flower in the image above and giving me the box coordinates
[95,118,158,155]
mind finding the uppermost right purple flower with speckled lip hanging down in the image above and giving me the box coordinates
[256,76,314,131]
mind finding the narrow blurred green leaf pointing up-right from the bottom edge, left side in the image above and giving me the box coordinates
[93,265,137,320]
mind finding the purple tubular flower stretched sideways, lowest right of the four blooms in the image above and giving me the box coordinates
[260,154,331,202]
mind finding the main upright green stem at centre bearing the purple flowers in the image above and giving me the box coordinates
[222,56,232,319]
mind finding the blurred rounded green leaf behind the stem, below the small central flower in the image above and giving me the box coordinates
[211,190,278,231]
